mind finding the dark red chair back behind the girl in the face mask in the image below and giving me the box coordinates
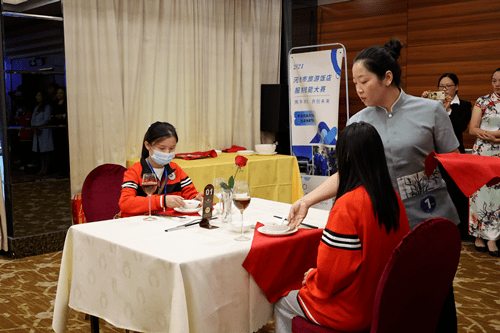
[82,164,127,222]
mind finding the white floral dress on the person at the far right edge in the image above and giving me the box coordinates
[469,93,500,240]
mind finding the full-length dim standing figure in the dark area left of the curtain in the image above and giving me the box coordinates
[31,91,54,176]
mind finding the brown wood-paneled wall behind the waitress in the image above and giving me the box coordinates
[318,0,500,148]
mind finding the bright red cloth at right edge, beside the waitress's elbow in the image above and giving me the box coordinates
[425,152,500,197]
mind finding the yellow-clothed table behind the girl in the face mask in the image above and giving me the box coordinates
[126,151,304,203]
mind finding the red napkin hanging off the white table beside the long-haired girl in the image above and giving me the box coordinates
[243,222,323,303]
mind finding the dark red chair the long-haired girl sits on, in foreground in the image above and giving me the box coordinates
[292,217,462,333]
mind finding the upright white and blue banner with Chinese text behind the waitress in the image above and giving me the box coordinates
[289,49,344,209]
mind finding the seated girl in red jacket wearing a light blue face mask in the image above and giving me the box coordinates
[119,121,202,217]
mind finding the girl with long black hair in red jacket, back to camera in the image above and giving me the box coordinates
[274,122,410,333]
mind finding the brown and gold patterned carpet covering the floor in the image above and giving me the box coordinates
[0,241,500,333]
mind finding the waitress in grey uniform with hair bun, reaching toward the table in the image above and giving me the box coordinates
[288,39,459,332]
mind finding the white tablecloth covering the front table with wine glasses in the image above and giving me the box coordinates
[53,198,328,333]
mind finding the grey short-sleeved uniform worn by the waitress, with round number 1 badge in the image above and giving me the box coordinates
[347,89,460,229]
